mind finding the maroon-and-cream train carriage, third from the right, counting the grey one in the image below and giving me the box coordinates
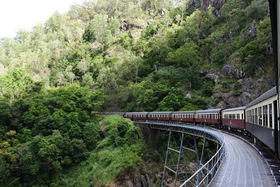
[195,109,222,125]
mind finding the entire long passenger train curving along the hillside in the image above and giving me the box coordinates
[103,87,280,155]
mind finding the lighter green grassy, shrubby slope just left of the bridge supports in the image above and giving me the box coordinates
[49,115,150,186]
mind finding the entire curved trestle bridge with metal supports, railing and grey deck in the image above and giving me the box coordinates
[134,121,277,187]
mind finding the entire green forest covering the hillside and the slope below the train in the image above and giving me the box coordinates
[0,0,275,186]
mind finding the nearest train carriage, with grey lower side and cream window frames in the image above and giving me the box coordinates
[245,87,279,151]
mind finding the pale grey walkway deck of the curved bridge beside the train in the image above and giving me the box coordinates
[211,133,277,187]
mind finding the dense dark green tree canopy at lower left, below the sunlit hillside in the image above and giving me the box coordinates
[0,86,104,185]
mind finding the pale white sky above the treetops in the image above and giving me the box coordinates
[0,0,85,38]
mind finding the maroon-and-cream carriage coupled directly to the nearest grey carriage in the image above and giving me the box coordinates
[222,106,245,130]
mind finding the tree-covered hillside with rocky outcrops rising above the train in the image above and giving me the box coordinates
[0,0,274,111]
